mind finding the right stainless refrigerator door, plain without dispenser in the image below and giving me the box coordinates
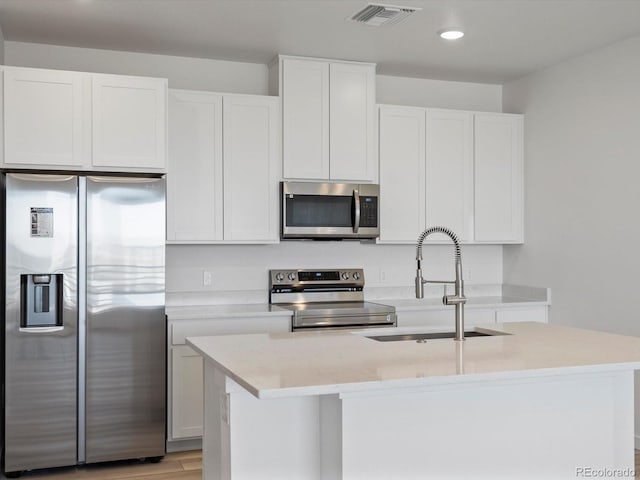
[85,177,166,463]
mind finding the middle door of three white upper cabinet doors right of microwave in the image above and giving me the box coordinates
[425,109,473,242]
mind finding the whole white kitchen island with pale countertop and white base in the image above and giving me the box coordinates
[187,323,640,480]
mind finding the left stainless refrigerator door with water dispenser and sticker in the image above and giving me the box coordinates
[4,174,78,472]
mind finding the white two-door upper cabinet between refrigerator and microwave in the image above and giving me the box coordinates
[167,90,282,243]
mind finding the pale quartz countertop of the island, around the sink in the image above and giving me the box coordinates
[187,322,640,398]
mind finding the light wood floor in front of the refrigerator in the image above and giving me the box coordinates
[3,450,640,480]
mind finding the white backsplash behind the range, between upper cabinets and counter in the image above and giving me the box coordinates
[166,241,502,304]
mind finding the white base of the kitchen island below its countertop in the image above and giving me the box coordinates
[203,362,634,480]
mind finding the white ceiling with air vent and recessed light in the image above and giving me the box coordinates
[0,0,640,83]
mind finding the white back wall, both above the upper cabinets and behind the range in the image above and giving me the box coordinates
[5,42,502,302]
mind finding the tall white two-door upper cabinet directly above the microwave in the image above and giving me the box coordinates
[271,56,377,182]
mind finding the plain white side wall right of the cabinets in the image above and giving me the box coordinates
[504,37,640,448]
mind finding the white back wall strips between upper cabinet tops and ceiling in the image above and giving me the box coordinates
[5,42,502,112]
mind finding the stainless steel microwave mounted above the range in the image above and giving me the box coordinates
[280,182,380,240]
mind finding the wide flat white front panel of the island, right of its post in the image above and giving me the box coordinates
[340,371,634,480]
